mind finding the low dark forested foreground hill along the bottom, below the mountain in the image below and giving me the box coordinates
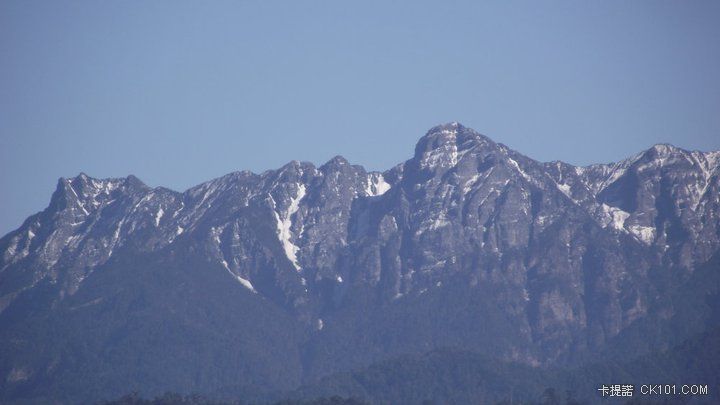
[98,328,720,405]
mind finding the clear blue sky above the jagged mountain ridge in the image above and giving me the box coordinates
[0,0,720,234]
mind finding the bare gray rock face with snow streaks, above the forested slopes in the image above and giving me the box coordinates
[0,123,720,400]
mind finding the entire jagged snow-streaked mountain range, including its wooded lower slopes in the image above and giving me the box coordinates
[0,123,720,403]
